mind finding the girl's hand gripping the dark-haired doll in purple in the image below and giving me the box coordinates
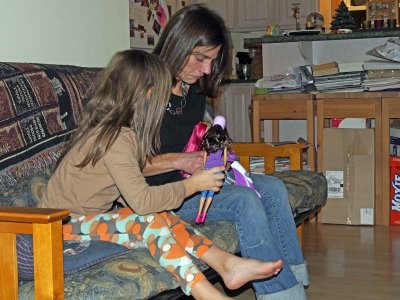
[183,166,225,197]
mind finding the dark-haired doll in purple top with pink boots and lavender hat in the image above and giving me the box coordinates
[196,116,232,224]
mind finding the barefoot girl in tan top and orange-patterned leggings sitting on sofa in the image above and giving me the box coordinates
[42,50,282,299]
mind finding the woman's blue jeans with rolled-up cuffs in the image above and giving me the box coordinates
[177,174,308,295]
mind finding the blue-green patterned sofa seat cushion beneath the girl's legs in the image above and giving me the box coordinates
[19,221,238,299]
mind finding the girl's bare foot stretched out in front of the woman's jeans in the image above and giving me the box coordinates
[221,256,282,290]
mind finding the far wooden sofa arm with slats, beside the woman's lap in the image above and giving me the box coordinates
[232,143,308,174]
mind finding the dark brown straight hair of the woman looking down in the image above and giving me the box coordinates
[153,5,232,97]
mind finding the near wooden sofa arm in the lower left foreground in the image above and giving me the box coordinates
[0,206,70,299]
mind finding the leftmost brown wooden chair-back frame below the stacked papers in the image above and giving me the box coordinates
[252,94,315,171]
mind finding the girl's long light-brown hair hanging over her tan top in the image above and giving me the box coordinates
[58,50,171,169]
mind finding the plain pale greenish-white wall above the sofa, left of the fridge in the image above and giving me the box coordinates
[0,0,129,67]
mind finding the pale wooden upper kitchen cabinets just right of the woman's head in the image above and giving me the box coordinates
[194,0,317,32]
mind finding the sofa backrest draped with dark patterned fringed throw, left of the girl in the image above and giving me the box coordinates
[0,63,100,206]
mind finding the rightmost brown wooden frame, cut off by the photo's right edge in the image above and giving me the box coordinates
[381,92,400,225]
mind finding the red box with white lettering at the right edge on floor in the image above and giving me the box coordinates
[390,156,400,225]
